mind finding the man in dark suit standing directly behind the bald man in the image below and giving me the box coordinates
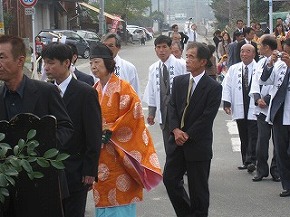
[234,27,259,64]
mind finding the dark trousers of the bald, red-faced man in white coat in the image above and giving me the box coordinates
[236,119,258,165]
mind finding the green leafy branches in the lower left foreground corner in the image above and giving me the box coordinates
[0,129,69,203]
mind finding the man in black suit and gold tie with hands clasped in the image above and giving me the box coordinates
[163,42,222,217]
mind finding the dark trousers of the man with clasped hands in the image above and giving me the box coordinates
[163,147,211,217]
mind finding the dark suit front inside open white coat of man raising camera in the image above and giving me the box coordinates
[270,68,290,122]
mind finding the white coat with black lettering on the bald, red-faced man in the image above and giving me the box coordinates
[222,60,257,120]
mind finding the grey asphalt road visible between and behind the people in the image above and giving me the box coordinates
[78,36,290,217]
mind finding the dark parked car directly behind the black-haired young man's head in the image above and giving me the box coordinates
[38,29,91,59]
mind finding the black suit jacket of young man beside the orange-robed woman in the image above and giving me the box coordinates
[62,78,102,192]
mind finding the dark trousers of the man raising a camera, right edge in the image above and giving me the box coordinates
[273,109,290,190]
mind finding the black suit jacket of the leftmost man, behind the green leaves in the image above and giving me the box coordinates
[0,75,73,147]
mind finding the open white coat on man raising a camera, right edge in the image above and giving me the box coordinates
[259,60,290,125]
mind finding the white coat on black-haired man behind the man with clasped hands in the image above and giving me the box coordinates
[143,54,187,124]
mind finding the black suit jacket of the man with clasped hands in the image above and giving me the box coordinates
[168,74,222,161]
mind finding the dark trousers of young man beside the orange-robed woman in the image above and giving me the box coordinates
[63,188,88,217]
